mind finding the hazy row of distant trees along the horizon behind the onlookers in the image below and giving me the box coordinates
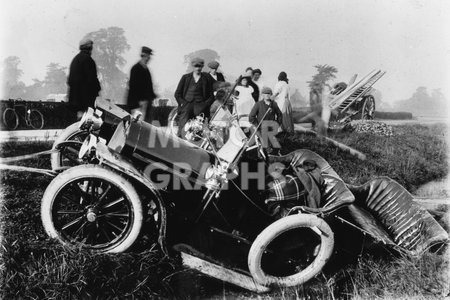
[1,27,446,114]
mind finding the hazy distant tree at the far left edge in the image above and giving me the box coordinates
[1,56,25,98]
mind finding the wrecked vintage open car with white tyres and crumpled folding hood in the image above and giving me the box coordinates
[41,100,448,292]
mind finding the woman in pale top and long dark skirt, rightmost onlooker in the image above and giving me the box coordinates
[273,72,294,132]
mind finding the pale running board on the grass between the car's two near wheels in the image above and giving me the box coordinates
[180,251,270,293]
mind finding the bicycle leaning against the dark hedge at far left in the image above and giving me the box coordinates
[3,99,44,130]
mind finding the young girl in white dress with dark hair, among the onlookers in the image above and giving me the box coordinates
[234,71,255,127]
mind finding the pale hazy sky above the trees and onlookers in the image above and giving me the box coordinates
[0,0,450,101]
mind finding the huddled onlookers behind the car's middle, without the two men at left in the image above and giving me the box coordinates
[175,58,294,136]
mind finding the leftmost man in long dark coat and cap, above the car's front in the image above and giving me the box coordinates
[67,39,101,119]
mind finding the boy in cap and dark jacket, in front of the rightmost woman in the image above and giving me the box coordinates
[248,87,283,155]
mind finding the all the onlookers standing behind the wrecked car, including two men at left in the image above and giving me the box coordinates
[67,39,294,142]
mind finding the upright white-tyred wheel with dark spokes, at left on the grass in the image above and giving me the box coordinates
[41,165,143,253]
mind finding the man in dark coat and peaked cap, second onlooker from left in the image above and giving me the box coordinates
[127,46,156,123]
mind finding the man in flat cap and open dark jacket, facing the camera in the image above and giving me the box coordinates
[175,58,214,138]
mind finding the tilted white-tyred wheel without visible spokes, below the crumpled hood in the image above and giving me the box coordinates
[248,214,334,287]
